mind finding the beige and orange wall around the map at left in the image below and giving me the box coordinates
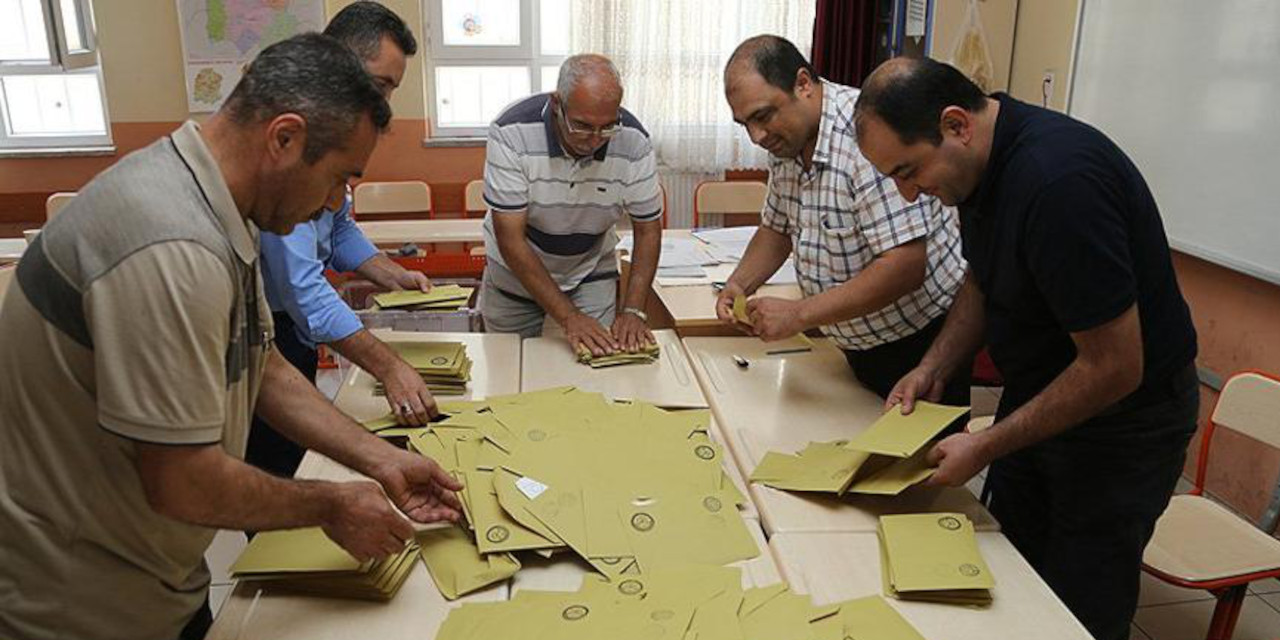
[0,0,484,222]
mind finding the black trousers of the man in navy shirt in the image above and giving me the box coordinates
[987,366,1199,640]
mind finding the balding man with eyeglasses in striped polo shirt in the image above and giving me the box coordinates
[480,54,663,356]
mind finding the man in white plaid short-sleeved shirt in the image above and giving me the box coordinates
[716,36,969,404]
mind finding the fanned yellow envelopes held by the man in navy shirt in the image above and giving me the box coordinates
[751,402,969,495]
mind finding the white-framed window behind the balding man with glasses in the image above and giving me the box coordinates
[422,0,570,137]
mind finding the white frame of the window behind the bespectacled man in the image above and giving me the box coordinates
[422,0,568,142]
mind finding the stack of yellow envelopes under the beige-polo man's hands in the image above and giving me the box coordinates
[230,527,417,600]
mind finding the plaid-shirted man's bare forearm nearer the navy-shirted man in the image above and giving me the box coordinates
[800,239,927,330]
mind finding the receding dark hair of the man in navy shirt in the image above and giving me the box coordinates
[854,58,987,145]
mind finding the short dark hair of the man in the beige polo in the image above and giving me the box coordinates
[223,33,392,163]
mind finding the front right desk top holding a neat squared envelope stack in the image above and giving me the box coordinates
[769,532,1092,640]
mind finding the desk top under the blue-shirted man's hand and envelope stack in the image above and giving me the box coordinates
[333,330,520,420]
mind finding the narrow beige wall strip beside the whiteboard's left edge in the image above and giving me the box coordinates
[1009,0,1080,111]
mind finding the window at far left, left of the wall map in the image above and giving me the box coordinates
[0,0,111,148]
